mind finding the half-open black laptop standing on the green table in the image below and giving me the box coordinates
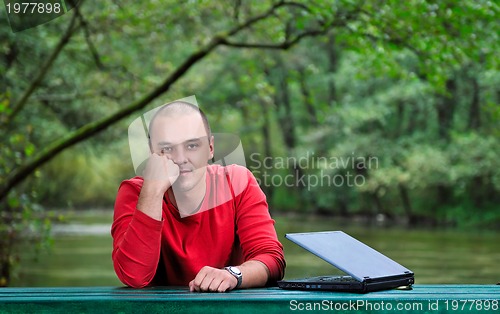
[278,231,415,293]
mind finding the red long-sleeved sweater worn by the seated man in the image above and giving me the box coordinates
[111,165,285,288]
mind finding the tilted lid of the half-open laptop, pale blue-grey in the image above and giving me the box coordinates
[286,231,411,281]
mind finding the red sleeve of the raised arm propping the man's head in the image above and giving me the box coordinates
[111,178,163,288]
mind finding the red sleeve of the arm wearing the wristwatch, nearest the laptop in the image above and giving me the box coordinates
[232,167,286,283]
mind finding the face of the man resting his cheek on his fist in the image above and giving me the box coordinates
[150,112,214,194]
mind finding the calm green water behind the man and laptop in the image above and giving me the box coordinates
[12,214,500,286]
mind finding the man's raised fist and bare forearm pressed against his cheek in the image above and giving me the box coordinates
[137,154,179,220]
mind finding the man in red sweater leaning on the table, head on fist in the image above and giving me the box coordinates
[111,101,285,292]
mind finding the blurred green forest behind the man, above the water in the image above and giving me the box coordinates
[0,0,500,286]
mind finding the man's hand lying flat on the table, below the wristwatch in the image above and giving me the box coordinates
[189,266,238,292]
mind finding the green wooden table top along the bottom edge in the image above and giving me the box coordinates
[0,285,500,314]
